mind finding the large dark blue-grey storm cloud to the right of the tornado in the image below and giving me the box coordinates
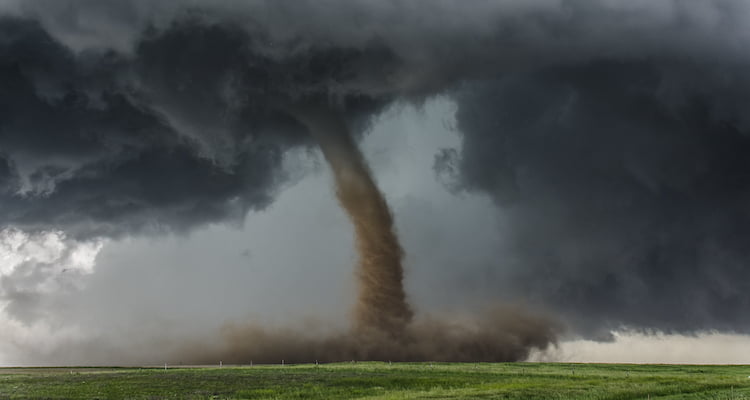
[444,59,750,338]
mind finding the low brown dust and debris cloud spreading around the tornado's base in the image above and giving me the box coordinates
[214,306,559,364]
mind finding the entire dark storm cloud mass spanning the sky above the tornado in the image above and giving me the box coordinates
[0,0,750,346]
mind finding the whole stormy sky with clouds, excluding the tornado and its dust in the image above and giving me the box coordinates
[0,0,750,365]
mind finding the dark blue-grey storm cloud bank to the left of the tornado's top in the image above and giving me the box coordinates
[0,14,400,236]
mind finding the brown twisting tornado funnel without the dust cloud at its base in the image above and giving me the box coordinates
[293,106,413,337]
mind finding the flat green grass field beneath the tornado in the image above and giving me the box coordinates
[0,362,750,400]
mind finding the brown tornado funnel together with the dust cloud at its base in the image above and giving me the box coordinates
[196,106,560,363]
